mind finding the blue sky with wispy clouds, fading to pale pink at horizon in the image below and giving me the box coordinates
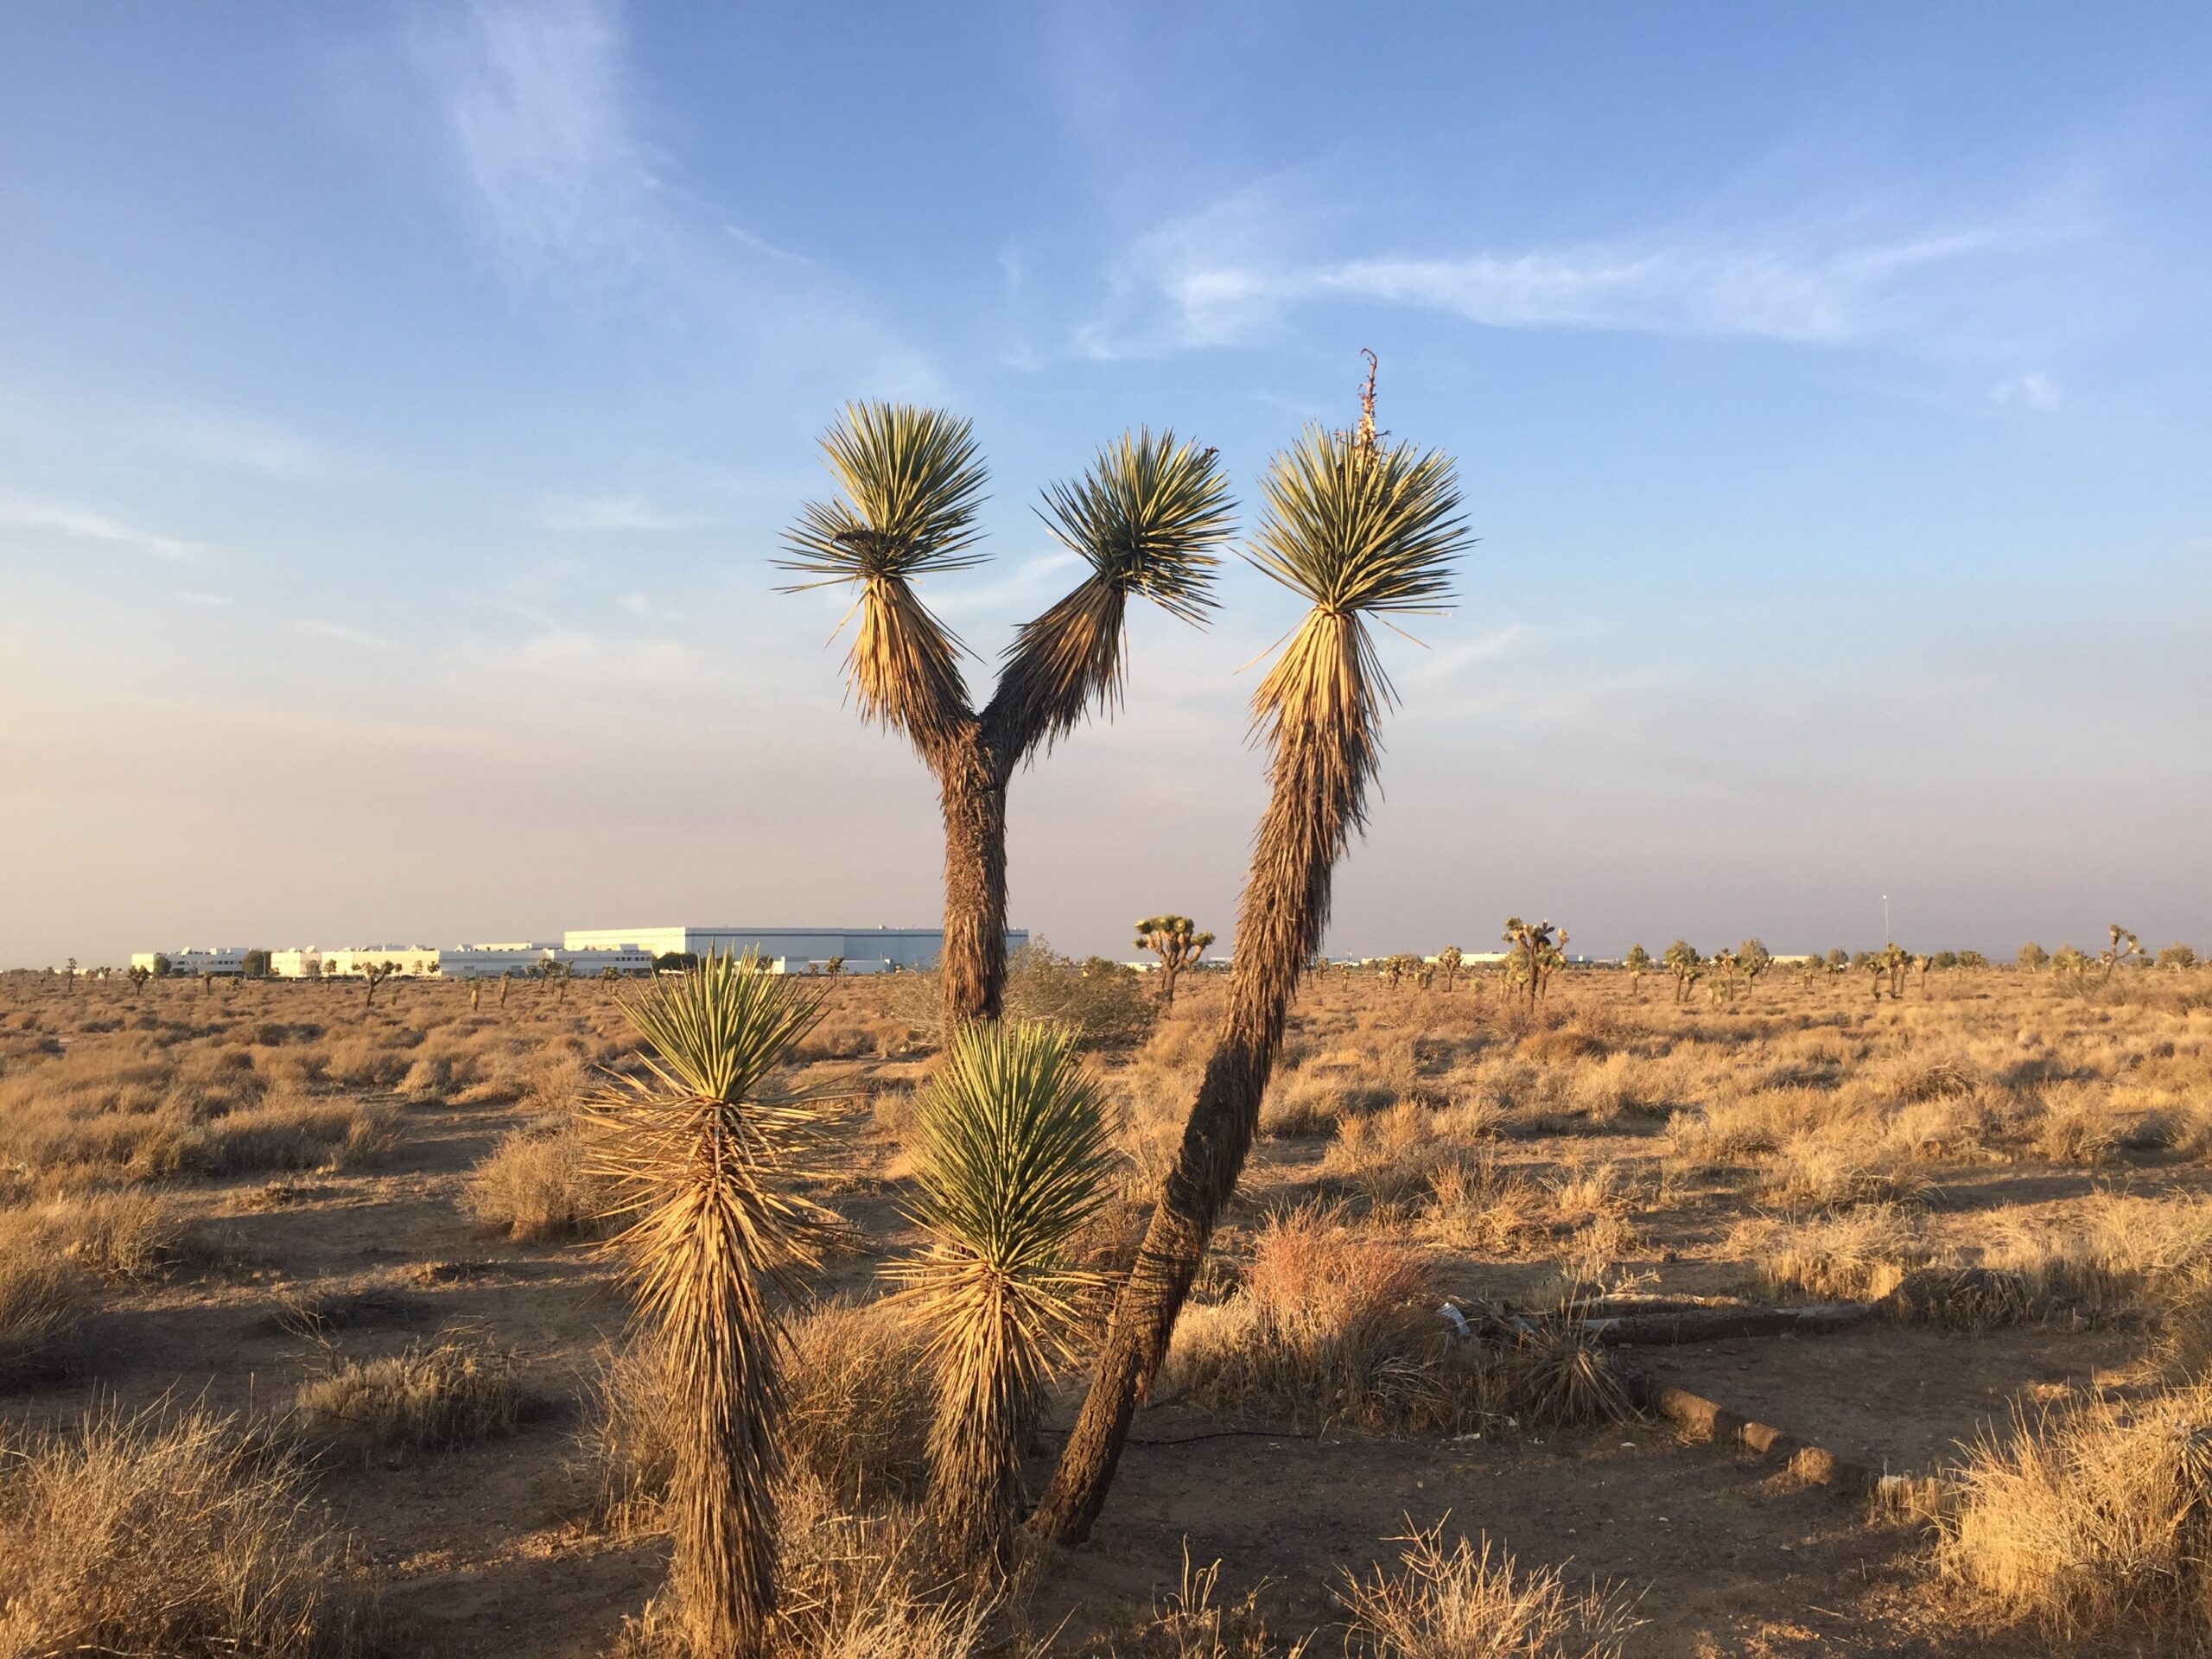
[0,3,2212,964]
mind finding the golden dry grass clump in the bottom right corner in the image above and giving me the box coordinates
[1940,1385,2212,1643]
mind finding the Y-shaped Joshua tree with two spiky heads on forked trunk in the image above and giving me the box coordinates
[779,403,1234,1031]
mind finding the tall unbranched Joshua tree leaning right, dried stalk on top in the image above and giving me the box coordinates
[1031,359,1469,1544]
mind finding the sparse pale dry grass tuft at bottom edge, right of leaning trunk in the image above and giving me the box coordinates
[1338,1522,1643,1659]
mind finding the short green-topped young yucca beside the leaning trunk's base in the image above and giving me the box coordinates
[892,1022,1113,1566]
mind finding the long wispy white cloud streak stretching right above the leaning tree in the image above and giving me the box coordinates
[1075,175,2086,359]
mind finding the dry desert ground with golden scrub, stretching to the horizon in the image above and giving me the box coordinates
[0,957,2212,1659]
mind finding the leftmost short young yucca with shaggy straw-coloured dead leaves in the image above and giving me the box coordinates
[586,951,830,1659]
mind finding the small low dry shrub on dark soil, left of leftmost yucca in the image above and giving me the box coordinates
[294,1336,526,1451]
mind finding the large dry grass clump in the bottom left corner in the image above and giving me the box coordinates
[0,1409,365,1659]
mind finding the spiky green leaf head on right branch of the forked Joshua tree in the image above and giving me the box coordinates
[1038,427,1236,621]
